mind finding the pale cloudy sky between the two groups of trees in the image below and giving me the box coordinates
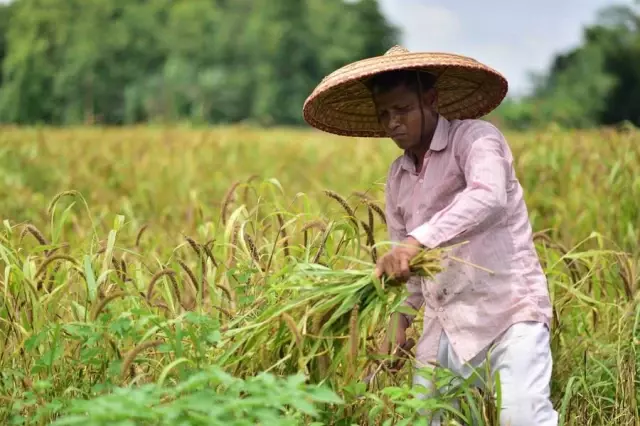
[379,0,632,95]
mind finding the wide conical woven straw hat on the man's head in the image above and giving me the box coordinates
[302,46,508,137]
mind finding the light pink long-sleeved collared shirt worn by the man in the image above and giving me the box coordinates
[385,116,552,363]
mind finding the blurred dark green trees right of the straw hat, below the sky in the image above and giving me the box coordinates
[492,1,640,129]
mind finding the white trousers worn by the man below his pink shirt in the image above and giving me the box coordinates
[413,322,558,426]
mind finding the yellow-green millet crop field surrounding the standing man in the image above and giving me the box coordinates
[0,122,640,426]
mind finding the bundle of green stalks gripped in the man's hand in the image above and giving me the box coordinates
[229,250,442,377]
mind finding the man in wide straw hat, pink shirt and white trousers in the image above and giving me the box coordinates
[303,46,558,426]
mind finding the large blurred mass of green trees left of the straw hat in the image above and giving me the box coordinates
[0,0,397,125]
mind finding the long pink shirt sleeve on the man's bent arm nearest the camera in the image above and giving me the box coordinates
[409,126,511,248]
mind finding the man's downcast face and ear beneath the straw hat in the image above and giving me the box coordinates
[374,85,437,150]
